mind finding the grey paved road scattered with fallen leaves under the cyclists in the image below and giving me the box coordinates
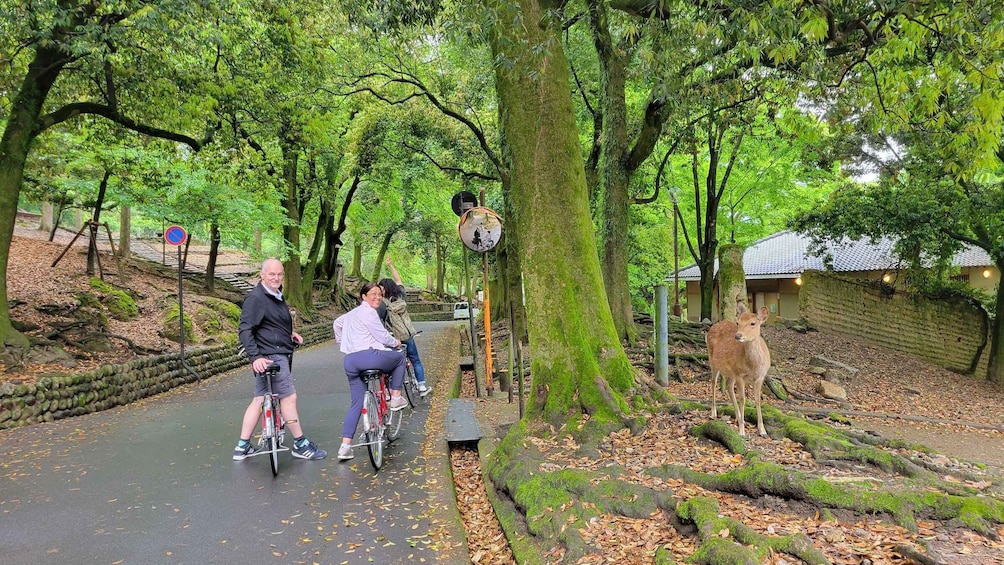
[0,322,469,565]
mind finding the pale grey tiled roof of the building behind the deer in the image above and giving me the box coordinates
[679,231,993,281]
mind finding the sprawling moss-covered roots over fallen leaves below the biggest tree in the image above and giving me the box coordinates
[486,397,1004,565]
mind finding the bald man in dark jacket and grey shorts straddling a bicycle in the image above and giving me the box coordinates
[234,259,327,461]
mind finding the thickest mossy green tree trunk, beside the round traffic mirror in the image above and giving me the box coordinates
[484,0,634,426]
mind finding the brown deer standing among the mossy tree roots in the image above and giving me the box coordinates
[706,302,770,438]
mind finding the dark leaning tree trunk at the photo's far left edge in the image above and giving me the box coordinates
[0,40,66,347]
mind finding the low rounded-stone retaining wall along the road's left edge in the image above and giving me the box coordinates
[0,320,332,430]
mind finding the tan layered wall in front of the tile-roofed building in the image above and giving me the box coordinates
[798,271,989,373]
